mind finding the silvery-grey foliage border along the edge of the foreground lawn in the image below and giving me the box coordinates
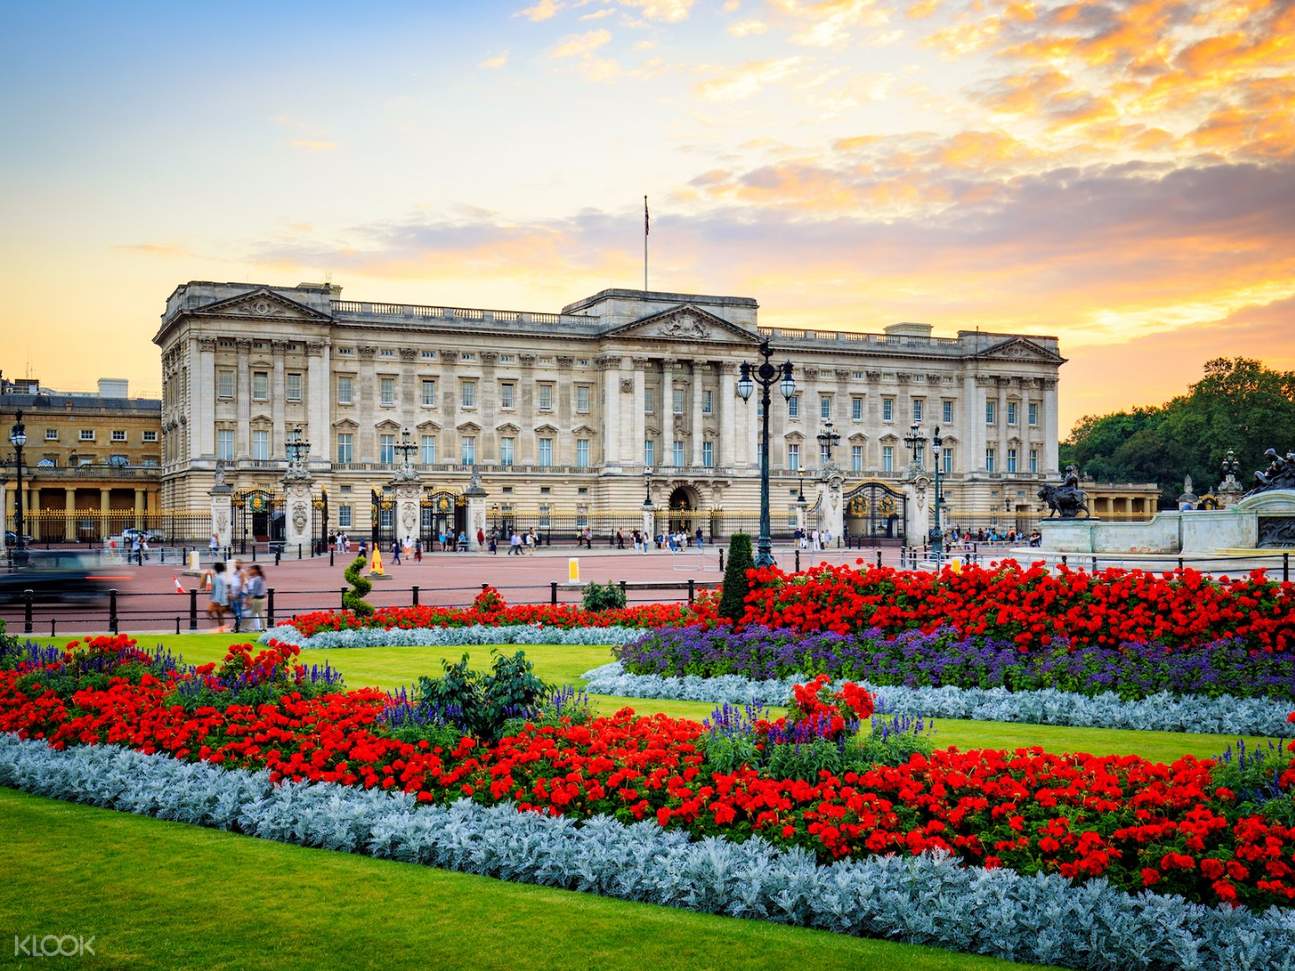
[10,734,1295,971]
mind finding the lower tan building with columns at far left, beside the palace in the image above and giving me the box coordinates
[0,378,162,542]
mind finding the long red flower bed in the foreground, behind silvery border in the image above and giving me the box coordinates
[0,638,1295,906]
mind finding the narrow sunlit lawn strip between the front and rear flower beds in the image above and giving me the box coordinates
[25,634,1269,761]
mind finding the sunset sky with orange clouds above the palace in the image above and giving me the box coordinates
[0,0,1295,429]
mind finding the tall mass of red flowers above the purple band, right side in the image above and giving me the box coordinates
[742,561,1295,653]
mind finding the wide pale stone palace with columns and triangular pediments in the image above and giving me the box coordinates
[154,281,1064,548]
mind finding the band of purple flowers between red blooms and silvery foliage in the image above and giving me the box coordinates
[615,625,1295,702]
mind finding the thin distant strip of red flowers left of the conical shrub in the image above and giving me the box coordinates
[287,586,714,637]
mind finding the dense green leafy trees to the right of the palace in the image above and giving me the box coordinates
[1061,357,1295,505]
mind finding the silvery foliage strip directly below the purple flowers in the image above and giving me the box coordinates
[581,662,1290,738]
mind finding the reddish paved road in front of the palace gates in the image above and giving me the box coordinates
[0,546,942,634]
